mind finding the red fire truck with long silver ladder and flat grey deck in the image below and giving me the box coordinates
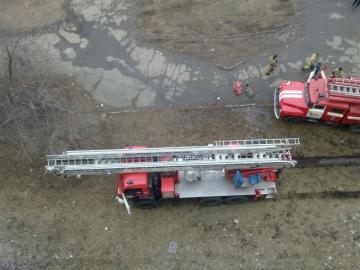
[46,138,300,213]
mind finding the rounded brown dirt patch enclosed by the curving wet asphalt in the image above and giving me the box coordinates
[137,0,298,65]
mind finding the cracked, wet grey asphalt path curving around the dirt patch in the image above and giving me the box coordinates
[45,0,360,108]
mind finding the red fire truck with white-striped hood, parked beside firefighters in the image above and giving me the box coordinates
[274,71,360,132]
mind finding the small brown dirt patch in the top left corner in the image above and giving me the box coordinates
[0,0,63,34]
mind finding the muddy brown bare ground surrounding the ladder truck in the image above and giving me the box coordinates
[0,83,360,269]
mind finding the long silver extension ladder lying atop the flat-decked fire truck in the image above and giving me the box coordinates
[46,138,300,175]
